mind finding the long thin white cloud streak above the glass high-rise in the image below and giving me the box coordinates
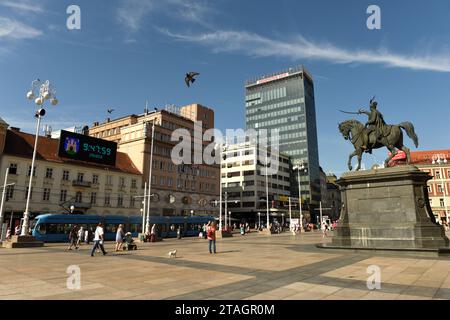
[160,29,450,72]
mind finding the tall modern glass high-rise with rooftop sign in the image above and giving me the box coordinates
[245,66,321,215]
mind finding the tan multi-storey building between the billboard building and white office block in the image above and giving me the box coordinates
[89,104,219,215]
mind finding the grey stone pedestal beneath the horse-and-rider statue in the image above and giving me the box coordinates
[324,166,449,250]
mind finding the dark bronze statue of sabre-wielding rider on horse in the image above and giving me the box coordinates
[339,97,419,171]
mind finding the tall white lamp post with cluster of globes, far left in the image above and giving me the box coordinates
[21,79,58,236]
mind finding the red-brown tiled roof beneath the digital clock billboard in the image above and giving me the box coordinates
[4,130,141,175]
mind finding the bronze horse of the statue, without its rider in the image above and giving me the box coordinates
[339,120,419,171]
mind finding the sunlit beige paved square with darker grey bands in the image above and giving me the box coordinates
[0,232,450,300]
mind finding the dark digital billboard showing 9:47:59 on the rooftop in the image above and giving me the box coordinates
[58,130,117,166]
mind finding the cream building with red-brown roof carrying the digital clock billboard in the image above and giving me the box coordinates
[0,121,142,229]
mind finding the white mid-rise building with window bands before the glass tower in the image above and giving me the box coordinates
[221,142,298,223]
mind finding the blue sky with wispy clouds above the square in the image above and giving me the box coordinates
[0,0,450,174]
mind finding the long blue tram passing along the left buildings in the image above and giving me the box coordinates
[32,214,215,242]
